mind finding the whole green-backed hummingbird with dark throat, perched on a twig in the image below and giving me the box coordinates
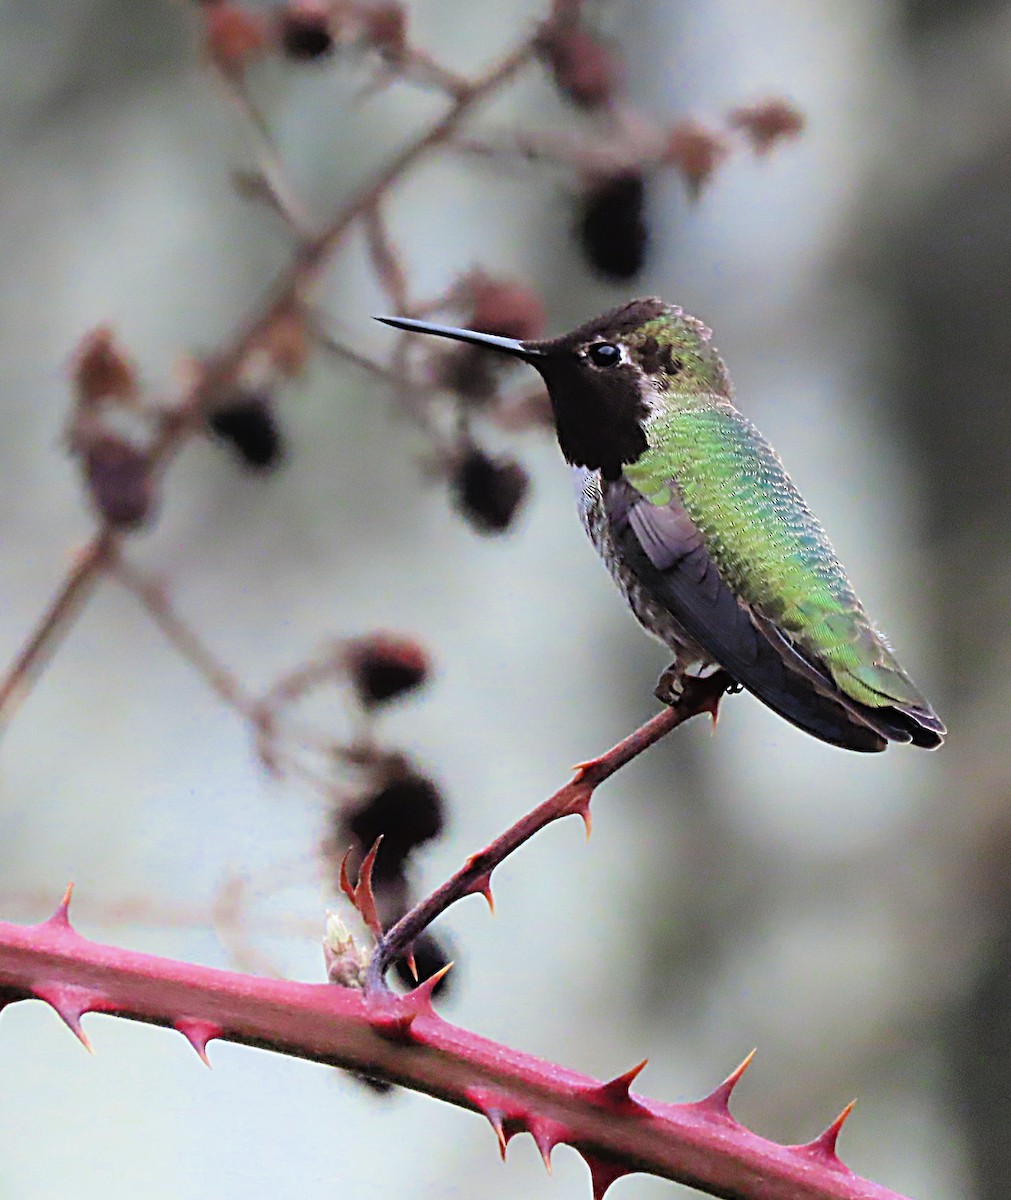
[377,298,946,751]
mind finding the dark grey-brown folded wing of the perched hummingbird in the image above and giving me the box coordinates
[606,481,944,751]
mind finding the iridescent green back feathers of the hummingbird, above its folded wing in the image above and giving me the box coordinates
[626,391,927,707]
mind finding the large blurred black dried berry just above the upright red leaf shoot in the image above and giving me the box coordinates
[345,768,443,882]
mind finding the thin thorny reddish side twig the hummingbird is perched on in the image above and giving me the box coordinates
[366,671,731,991]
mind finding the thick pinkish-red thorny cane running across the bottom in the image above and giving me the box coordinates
[0,902,903,1200]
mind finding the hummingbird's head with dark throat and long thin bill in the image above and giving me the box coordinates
[378,298,730,479]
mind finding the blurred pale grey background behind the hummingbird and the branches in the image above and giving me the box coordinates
[0,0,1011,1200]
